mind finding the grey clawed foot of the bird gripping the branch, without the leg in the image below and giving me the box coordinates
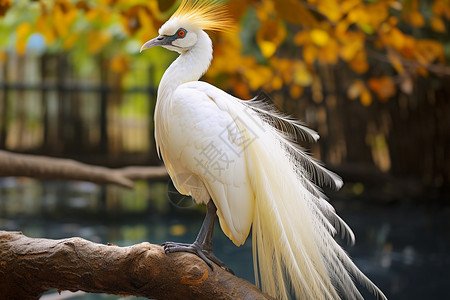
[161,242,234,275]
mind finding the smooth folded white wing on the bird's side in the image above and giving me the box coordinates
[162,82,254,245]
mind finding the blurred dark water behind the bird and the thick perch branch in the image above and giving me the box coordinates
[0,178,450,300]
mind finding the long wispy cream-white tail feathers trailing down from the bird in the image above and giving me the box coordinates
[232,101,386,299]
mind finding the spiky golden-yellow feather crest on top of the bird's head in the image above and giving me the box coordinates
[170,0,234,31]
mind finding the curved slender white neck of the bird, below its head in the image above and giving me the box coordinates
[158,31,212,99]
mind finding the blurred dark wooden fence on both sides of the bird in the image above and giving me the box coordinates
[0,54,450,192]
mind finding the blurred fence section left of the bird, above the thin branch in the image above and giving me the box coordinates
[0,54,156,164]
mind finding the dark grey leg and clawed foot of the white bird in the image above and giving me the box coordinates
[162,200,233,273]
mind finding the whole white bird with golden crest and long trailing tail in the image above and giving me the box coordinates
[141,0,386,300]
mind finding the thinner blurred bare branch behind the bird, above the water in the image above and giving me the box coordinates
[0,151,167,188]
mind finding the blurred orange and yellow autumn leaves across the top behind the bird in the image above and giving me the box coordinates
[0,0,450,106]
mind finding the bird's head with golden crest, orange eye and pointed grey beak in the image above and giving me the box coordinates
[141,0,233,53]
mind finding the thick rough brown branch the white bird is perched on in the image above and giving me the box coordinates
[0,231,271,300]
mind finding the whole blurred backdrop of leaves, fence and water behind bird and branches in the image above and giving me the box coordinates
[0,0,450,299]
